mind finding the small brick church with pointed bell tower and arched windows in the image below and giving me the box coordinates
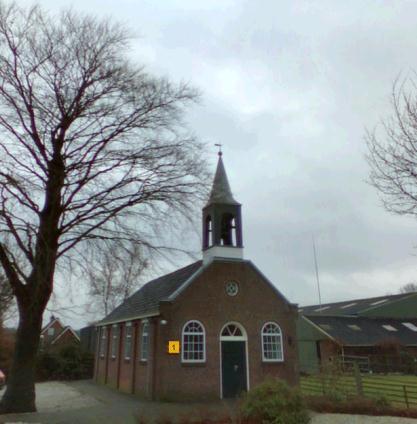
[95,152,298,400]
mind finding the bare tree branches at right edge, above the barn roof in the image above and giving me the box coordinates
[366,77,417,217]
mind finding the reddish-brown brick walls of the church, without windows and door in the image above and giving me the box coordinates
[95,260,298,400]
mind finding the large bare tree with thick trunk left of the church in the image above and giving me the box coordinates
[0,2,206,413]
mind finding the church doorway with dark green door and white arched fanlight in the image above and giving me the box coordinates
[220,324,247,398]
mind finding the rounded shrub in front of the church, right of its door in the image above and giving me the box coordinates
[241,378,310,424]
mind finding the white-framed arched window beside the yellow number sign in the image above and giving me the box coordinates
[181,321,206,362]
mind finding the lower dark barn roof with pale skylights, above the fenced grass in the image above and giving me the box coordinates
[306,315,417,346]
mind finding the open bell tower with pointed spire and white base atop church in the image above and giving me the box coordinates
[203,150,243,262]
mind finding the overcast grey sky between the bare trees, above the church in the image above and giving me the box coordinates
[18,0,417,327]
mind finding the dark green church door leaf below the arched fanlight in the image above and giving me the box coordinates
[222,341,247,398]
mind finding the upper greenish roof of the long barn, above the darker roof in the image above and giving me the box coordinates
[299,292,417,316]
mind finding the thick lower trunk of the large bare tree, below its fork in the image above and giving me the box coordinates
[0,305,43,414]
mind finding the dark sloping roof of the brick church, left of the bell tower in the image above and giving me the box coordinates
[98,261,203,325]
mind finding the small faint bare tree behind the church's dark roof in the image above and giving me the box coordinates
[84,241,149,316]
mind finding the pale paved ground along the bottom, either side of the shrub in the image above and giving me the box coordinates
[0,381,417,424]
